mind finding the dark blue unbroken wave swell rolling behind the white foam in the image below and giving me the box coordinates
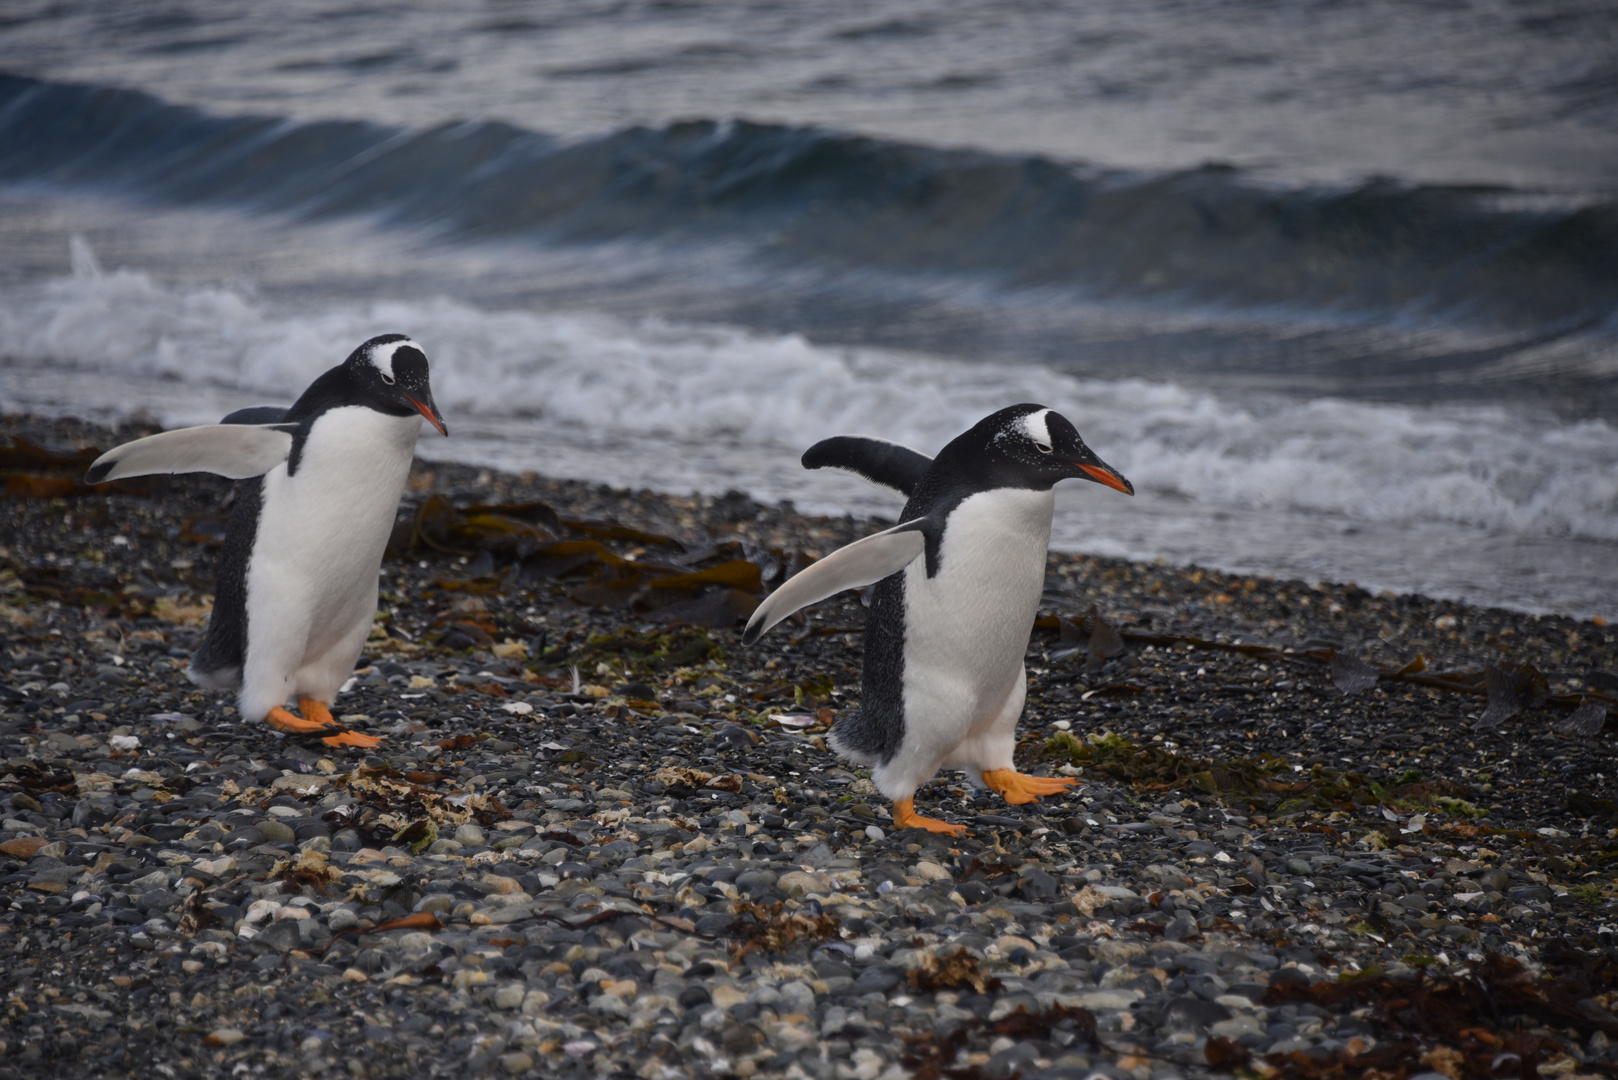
[0,76,1618,340]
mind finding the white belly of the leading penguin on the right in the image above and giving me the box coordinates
[900,489,1055,764]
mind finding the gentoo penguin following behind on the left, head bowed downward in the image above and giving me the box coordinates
[86,334,450,746]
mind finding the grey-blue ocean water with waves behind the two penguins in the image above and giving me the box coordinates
[0,0,1618,615]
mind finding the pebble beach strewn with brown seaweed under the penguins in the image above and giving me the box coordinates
[0,418,1618,1080]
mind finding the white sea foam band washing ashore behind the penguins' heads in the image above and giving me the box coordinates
[0,240,1618,553]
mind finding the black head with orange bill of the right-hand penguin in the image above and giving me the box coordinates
[940,405,1134,495]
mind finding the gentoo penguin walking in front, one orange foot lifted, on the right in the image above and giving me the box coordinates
[743,405,1134,836]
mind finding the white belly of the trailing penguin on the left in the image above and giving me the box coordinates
[241,406,421,719]
